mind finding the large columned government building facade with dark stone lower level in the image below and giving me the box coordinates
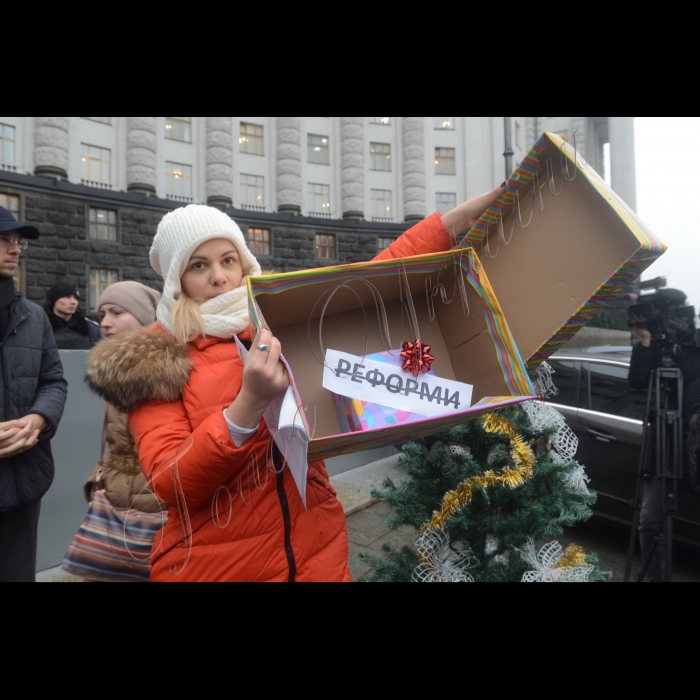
[0,117,636,313]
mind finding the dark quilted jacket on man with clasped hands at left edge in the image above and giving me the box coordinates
[0,293,68,513]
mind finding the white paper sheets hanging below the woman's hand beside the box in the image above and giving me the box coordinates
[236,338,309,507]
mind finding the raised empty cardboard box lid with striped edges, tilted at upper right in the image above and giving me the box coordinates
[463,133,666,369]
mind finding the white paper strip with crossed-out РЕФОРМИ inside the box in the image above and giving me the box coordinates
[323,350,474,418]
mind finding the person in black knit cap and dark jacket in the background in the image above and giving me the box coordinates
[44,282,102,350]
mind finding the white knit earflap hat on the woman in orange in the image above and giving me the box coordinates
[151,204,261,299]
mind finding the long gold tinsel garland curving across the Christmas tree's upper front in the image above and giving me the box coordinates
[421,413,537,535]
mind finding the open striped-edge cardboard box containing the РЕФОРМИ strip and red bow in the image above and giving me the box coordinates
[249,249,535,460]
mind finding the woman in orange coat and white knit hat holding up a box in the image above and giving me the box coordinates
[88,188,503,582]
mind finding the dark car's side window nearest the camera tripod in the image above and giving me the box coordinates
[582,362,647,421]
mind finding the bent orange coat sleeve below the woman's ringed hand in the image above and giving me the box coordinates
[129,401,260,508]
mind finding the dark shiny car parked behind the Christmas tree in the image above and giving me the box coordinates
[549,348,700,546]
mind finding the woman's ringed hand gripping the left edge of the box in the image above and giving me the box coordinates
[226,330,289,430]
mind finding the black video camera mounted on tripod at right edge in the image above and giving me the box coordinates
[626,277,700,345]
